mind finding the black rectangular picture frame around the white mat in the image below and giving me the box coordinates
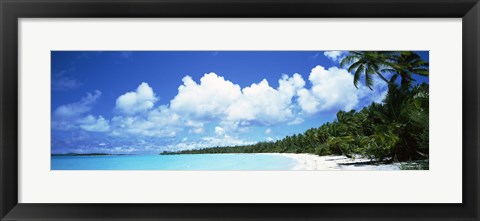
[0,0,480,221]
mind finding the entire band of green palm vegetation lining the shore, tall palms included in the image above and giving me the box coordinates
[161,51,429,165]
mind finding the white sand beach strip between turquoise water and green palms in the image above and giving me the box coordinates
[269,153,400,170]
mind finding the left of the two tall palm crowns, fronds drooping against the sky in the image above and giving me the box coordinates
[340,51,394,90]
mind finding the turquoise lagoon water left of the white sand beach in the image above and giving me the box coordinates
[51,154,296,170]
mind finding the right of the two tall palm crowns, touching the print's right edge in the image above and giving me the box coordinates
[382,51,428,86]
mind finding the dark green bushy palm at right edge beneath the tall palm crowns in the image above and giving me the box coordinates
[369,78,429,161]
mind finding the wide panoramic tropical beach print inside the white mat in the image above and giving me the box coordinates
[51,51,429,171]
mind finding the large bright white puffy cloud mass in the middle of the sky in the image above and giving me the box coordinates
[170,73,305,125]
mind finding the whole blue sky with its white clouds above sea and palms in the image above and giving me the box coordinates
[51,51,428,154]
